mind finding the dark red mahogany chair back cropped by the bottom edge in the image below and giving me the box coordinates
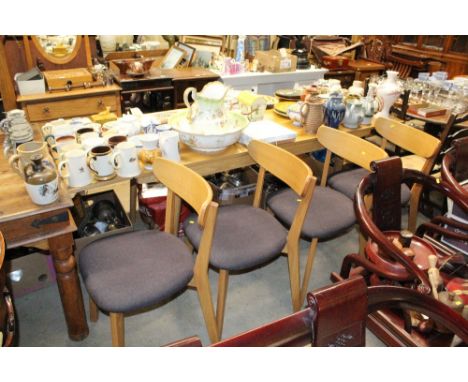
[167,276,468,347]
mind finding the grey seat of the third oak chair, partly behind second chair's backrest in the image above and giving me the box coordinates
[268,186,356,241]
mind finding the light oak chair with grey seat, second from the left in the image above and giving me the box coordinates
[184,141,316,337]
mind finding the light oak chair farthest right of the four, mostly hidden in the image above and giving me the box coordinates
[374,117,441,232]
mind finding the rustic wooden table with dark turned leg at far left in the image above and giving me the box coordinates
[0,136,89,341]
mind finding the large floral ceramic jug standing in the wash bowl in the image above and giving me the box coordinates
[184,81,229,128]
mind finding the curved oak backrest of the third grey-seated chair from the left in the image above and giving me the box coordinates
[317,125,388,171]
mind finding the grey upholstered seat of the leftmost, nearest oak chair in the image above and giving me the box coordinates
[79,231,194,313]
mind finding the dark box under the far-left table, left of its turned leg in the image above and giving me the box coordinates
[5,252,56,297]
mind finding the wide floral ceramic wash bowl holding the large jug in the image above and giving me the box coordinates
[168,111,249,153]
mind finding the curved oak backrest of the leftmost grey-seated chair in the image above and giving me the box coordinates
[153,158,213,227]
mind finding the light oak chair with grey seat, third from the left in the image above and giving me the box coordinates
[268,125,388,303]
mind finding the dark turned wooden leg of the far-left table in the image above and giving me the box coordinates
[49,233,89,341]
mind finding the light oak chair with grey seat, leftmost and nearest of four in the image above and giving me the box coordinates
[79,158,220,346]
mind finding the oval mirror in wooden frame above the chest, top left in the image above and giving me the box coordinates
[31,35,81,64]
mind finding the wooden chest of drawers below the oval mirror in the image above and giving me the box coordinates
[17,85,121,122]
